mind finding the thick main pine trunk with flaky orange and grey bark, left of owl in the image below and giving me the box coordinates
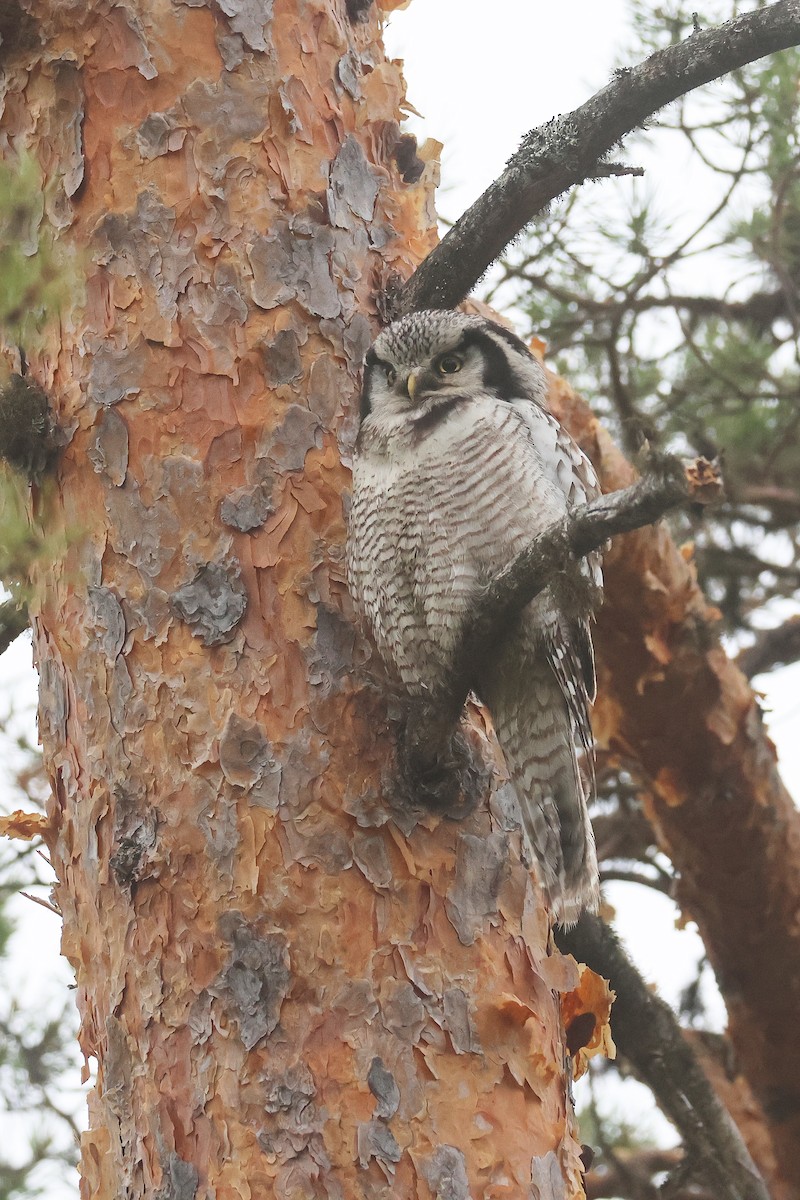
[9,0,601,1200]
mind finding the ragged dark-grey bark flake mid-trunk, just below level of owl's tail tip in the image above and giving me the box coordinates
[209,912,291,1050]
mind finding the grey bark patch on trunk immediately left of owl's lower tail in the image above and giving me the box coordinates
[445,833,509,946]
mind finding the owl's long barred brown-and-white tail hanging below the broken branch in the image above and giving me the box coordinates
[483,658,600,925]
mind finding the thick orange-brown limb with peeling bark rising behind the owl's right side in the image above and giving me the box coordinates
[551,380,800,1189]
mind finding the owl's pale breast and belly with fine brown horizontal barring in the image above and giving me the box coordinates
[348,398,565,690]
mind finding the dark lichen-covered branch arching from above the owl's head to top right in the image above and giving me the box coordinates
[397,0,800,313]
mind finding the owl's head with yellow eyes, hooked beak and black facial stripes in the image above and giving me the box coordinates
[361,310,547,421]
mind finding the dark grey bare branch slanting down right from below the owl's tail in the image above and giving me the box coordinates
[555,913,769,1200]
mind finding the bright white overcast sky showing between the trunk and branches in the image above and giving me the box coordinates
[0,0,800,1200]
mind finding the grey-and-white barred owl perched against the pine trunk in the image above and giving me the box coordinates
[347,311,602,924]
